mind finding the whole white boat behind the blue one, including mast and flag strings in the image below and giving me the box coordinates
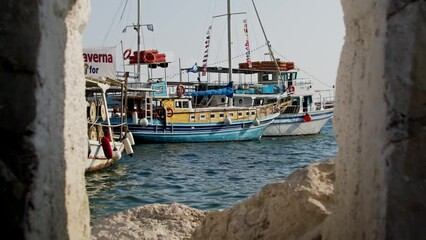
[178,0,334,137]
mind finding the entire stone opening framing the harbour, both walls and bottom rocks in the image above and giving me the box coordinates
[0,0,426,239]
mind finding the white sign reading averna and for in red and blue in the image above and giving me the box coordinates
[83,47,116,79]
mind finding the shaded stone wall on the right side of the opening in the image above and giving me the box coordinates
[324,0,426,239]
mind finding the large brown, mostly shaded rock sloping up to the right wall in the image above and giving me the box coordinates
[192,160,335,240]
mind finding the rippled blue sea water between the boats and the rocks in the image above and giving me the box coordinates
[86,121,337,221]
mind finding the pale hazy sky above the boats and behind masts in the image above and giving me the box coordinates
[83,0,345,88]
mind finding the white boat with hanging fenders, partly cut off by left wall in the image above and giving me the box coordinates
[85,77,134,173]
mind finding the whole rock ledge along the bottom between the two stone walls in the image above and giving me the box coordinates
[92,160,335,240]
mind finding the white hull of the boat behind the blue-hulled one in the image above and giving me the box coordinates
[262,109,333,137]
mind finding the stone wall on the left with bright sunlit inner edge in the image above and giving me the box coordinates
[0,0,90,239]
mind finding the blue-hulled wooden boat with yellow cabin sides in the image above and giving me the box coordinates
[111,83,280,143]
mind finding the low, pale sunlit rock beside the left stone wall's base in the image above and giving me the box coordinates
[91,203,205,240]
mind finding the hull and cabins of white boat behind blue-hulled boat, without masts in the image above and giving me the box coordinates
[234,68,334,137]
